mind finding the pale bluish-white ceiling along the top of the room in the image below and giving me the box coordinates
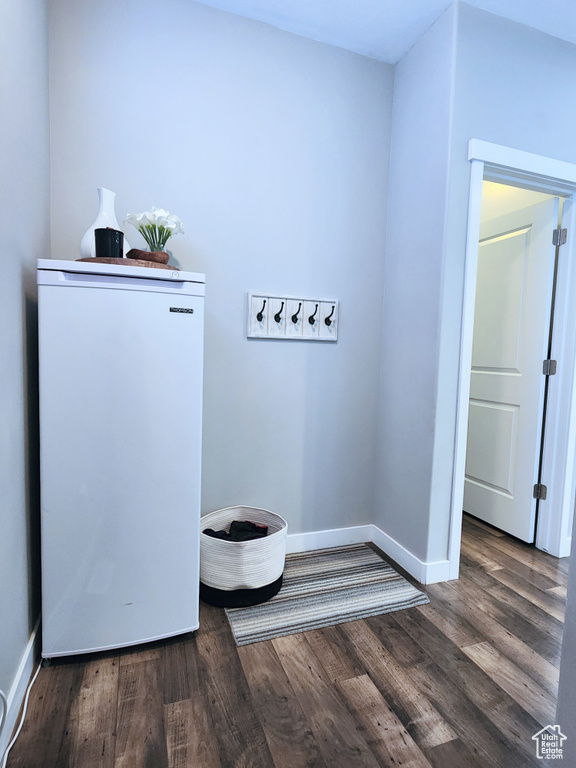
[196,0,576,64]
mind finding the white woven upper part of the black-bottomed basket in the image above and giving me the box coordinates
[200,507,288,591]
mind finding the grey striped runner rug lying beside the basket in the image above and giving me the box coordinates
[226,544,429,645]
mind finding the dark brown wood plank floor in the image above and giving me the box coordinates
[8,518,567,768]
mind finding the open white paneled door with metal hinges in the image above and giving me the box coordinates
[464,198,559,542]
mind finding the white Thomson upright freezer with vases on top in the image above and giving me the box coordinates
[37,259,204,658]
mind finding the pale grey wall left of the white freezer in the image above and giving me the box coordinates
[0,0,49,755]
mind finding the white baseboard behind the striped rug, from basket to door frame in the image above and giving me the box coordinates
[286,525,450,584]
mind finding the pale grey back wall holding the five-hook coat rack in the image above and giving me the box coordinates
[50,0,392,532]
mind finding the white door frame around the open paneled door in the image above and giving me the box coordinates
[448,139,576,579]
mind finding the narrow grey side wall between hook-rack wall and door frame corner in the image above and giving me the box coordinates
[374,3,455,561]
